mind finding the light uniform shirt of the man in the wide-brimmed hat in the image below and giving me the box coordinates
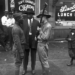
[38,22,51,42]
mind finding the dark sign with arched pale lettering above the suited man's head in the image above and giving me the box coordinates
[15,0,35,13]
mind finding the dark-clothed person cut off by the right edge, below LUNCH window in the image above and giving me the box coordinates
[66,29,75,66]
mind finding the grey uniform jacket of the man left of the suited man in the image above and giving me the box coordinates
[12,25,26,56]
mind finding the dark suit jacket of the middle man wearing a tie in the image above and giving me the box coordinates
[21,17,40,49]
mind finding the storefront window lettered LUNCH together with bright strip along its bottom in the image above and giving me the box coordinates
[55,2,75,26]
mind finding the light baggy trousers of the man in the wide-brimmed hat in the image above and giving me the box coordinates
[37,42,49,71]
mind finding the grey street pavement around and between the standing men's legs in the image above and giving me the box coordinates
[0,42,75,75]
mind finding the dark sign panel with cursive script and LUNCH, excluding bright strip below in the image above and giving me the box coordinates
[55,2,75,21]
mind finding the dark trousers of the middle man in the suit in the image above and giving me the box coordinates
[23,48,36,70]
